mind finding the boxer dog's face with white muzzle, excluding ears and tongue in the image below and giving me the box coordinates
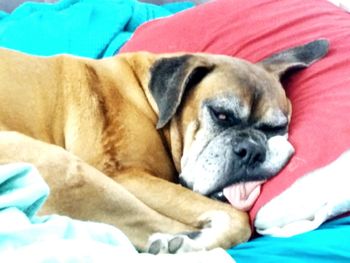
[179,57,293,198]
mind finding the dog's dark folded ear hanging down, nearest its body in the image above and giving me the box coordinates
[149,55,213,129]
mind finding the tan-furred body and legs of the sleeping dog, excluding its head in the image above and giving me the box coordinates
[0,50,252,252]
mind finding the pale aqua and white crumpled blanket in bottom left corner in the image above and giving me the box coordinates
[0,164,137,263]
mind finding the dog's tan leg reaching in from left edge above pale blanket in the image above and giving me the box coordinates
[0,132,194,250]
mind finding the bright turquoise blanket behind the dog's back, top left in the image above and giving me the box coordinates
[0,0,193,58]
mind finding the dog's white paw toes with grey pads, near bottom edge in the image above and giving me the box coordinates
[147,231,205,254]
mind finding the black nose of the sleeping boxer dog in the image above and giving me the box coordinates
[234,140,266,167]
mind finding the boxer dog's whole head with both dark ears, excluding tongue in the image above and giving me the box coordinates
[149,40,328,200]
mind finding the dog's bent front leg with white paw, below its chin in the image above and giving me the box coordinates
[115,170,251,254]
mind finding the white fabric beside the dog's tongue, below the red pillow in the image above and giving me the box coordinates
[254,151,350,237]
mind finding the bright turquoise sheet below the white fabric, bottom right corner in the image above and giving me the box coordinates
[228,216,350,263]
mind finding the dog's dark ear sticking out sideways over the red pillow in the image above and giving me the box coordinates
[258,39,329,77]
